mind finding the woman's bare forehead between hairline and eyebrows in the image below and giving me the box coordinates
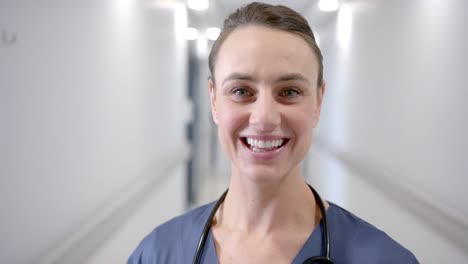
[214,26,318,83]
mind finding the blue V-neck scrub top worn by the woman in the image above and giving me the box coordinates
[127,203,419,264]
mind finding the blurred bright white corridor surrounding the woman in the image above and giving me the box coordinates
[0,0,468,264]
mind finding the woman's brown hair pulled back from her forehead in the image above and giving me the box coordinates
[208,2,323,87]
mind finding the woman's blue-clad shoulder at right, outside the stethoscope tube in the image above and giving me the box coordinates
[327,203,418,264]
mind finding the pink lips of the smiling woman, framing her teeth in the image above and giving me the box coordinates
[239,135,289,161]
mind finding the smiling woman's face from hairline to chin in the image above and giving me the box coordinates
[210,26,324,182]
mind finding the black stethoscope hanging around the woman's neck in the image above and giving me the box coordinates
[193,185,336,264]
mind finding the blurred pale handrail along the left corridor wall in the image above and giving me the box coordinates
[34,144,190,264]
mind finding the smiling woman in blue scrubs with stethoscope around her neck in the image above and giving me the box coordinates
[129,3,418,264]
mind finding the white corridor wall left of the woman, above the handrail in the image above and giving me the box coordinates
[0,0,188,263]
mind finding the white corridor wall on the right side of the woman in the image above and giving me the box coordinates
[309,0,468,263]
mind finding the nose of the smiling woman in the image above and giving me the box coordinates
[249,92,281,133]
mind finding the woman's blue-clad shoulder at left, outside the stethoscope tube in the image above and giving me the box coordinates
[127,203,214,264]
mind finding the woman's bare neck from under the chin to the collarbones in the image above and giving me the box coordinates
[218,167,319,235]
